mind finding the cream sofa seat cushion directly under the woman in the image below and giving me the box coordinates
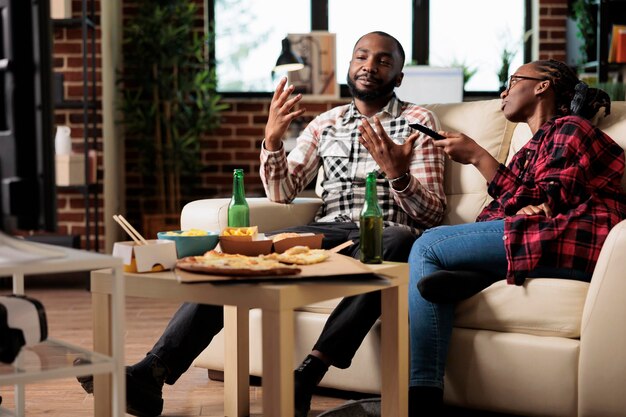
[454,278,589,338]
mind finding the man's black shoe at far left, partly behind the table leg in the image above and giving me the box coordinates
[74,357,166,417]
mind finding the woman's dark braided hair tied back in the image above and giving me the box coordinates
[534,59,611,119]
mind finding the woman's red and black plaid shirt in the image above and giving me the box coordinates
[478,116,626,285]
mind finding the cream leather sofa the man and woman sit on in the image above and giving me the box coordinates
[181,100,626,417]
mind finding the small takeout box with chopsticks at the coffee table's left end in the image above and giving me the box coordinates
[113,239,176,272]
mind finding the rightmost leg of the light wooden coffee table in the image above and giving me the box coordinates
[380,285,409,417]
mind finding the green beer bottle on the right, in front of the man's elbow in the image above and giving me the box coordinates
[359,172,383,264]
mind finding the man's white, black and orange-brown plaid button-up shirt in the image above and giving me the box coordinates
[260,95,446,233]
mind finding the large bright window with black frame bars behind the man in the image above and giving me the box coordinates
[207,0,532,93]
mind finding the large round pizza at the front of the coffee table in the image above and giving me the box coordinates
[176,250,301,276]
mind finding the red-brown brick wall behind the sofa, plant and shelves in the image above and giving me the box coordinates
[54,0,567,248]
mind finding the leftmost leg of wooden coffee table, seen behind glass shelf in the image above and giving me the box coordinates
[91,292,113,417]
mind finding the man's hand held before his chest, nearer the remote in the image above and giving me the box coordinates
[359,117,419,178]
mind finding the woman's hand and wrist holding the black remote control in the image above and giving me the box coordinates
[435,132,500,182]
